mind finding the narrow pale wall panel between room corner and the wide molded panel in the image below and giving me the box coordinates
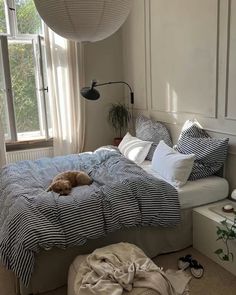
[122,0,148,111]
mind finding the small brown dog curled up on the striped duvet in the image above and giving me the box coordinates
[47,171,93,195]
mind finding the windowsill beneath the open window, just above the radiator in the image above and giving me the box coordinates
[6,138,53,152]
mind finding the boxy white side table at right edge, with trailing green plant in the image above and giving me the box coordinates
[193,200,236,275]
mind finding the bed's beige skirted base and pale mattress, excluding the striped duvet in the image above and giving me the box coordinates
[20,171,228,295]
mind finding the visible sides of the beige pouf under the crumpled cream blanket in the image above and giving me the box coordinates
[67,255,158,295]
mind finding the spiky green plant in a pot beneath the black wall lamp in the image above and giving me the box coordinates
[108,103,131,146]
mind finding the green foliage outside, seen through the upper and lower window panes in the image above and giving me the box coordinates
[0,0,41,132]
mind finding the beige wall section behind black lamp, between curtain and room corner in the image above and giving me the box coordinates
[84,31,124,151]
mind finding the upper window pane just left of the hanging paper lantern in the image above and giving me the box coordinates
[15,0,42,34]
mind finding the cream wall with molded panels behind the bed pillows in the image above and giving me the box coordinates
[122,0,236,192]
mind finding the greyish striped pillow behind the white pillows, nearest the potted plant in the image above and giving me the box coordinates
[135,115,172,161]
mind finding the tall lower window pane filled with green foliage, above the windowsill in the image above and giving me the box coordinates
[9,43,40,139]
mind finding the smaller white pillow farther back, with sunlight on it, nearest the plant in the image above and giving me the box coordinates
[118,132,152,164]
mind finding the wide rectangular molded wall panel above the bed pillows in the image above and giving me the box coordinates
[149,0,220,119]
